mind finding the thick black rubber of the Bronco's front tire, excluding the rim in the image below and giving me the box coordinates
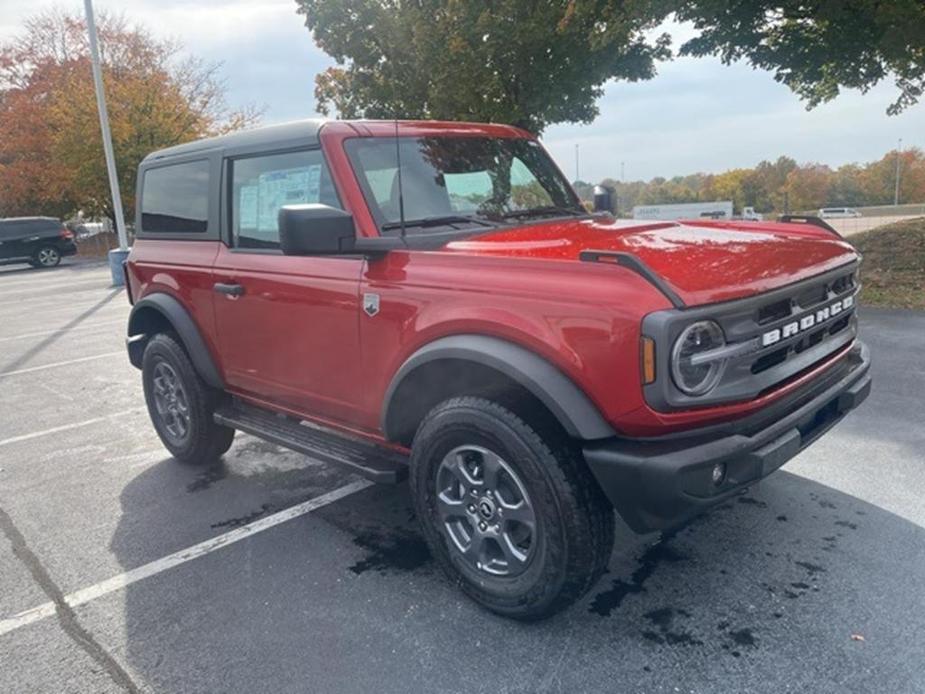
[410,397,614,620]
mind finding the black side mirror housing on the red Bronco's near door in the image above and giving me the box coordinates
[279,204,356,255]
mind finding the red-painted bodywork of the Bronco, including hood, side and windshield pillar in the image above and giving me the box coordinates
[129,122,857,438]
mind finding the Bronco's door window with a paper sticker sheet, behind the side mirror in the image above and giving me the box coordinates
[231,149,341,248]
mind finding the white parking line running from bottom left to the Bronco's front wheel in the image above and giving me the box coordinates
[0,480,372,636]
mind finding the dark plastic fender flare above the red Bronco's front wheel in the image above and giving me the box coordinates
[380,335,616,440]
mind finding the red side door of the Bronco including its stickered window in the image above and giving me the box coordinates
[213,149,364,423]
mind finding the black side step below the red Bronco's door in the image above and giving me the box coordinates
[215,401,408,484]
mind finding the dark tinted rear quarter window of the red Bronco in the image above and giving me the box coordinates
[141,159,209,234]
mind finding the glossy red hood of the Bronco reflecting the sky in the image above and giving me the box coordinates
[443,219,858,306]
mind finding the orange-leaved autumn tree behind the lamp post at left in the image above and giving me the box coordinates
[0,10,258,223]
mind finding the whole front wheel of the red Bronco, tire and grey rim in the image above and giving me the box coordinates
[410,397,614,620]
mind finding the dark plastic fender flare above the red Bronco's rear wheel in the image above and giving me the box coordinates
[127,292,225,389]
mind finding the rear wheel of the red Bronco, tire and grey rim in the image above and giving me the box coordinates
[141,333,234,465]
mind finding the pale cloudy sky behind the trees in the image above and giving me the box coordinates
[0,0,925,181]
